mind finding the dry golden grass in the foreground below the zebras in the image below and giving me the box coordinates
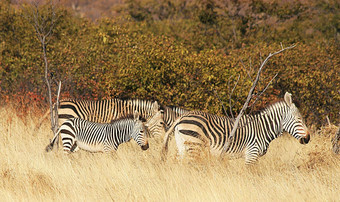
[0,107,340,201]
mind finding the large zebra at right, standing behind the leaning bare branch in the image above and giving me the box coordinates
[163,92,310,164]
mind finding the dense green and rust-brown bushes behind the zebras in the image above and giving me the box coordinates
[0,0,340,124]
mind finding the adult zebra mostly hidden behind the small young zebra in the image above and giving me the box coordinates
[34,98,165,145]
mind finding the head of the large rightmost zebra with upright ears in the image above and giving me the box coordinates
[282,92,310,144]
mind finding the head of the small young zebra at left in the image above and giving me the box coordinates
[131,111,149,150]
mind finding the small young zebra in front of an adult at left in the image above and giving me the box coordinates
[46,112,149,153]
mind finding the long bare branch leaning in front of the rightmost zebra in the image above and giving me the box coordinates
[222,45,295,153]
